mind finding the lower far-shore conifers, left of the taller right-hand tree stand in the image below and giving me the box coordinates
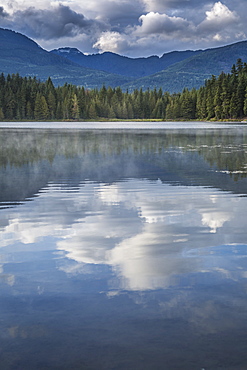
[0,74,167,121]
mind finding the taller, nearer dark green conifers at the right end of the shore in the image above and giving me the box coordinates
[166,58,247,120]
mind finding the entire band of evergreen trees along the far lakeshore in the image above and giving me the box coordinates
[0,59,247,121]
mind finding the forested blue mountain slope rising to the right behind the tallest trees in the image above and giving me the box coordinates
[124,41,247,92]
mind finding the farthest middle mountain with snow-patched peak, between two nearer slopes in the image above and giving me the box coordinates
[51,47,202,78]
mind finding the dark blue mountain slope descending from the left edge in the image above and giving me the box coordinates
[0,28,130,88]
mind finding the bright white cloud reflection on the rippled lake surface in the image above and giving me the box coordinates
[1,179,246,290]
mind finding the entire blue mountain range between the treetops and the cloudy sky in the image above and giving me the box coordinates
[0,28,247,93]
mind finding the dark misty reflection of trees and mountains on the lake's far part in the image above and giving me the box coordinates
[0,128,247,199]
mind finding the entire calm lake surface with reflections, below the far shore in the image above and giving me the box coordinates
[0,124,247,370]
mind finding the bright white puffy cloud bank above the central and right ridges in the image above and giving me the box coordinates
[93,0,245,56]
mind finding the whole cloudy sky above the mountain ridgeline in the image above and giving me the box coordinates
[0,0,247,57]
